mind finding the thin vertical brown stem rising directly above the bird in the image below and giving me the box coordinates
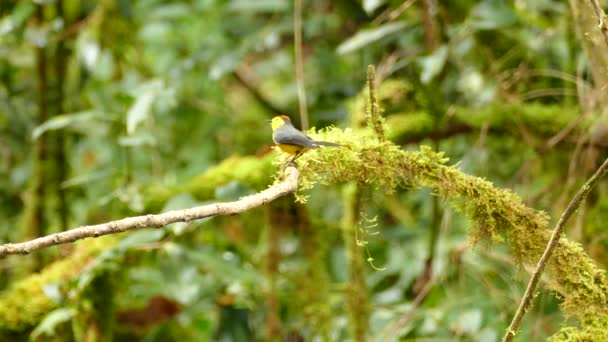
[293,0,308,131]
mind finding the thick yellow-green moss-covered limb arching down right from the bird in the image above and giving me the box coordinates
[299,128,608,340]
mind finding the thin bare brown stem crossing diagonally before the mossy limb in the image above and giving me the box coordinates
[502,159,608,342]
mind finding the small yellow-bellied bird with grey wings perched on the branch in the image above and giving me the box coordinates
[268,115,342,164]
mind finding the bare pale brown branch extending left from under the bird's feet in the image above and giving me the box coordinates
[0,167,300,257]
